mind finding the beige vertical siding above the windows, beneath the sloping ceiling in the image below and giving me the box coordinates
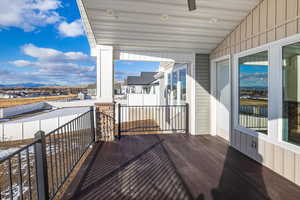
[211,0,300,58]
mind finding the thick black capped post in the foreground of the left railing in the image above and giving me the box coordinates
[34,131,49,200]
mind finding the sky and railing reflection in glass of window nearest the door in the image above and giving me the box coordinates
[239,51,269,134]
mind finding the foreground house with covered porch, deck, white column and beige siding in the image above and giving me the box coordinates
[0,0,300,200]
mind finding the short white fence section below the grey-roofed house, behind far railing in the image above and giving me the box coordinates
[127,94,159,106]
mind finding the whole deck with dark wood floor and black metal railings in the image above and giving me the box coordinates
[0,105,300,200]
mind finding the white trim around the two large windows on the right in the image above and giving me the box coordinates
[232,34,300,154]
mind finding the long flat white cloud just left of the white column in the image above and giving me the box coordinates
[22,44,91,62]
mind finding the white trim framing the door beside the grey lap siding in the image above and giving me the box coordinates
[210,55,232,135]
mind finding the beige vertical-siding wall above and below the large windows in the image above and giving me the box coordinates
[210,0,300,185]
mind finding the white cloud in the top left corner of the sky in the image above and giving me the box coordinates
[0,0,62,31]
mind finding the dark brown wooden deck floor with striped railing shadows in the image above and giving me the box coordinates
[64,134,300,200]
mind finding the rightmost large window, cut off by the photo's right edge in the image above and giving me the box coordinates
[282,42,300,145]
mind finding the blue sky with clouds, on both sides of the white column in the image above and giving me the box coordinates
[0,0,158,85]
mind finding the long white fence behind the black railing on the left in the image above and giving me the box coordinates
[0,107,89,142]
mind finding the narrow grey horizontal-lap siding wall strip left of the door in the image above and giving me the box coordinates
[195,54,210,134]
